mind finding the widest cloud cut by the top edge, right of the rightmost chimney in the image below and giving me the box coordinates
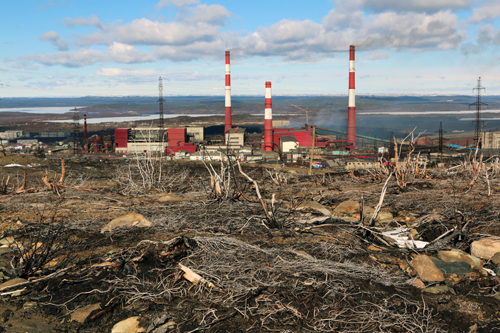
[362,0,472,12]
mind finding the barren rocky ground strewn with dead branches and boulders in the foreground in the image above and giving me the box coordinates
[0,156,500,333]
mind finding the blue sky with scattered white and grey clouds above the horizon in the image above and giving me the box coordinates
[0,0,500,98]
